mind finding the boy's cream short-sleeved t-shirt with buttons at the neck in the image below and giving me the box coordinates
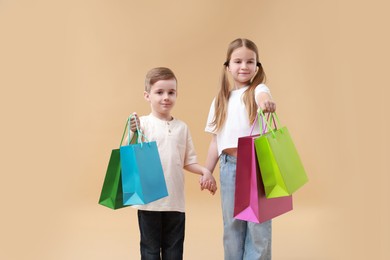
[133,114,197,212]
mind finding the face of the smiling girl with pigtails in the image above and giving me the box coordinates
[228,47,257,89]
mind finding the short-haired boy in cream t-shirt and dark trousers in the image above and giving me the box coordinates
[131,67,217,260]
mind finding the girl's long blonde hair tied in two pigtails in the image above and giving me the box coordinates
[211,38,265,131]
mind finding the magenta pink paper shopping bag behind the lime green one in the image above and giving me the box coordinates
[234,135,293,223]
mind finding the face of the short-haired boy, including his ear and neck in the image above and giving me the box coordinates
[144,79,177,120]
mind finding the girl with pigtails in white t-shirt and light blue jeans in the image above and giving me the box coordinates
[205,39,276,260]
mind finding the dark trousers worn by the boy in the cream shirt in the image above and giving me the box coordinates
[138,210,185,260]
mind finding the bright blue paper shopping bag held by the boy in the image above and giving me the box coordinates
[120,118,168,205]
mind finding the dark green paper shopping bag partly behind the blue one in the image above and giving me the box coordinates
[99,121,128,209]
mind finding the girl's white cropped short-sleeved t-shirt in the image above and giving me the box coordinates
[205,84,271,156]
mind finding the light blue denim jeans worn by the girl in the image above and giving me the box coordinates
[219,153,272,260]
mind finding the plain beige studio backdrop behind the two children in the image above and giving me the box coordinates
[0,0,390,260]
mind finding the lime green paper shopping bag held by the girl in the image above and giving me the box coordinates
[255,110,308,198]
